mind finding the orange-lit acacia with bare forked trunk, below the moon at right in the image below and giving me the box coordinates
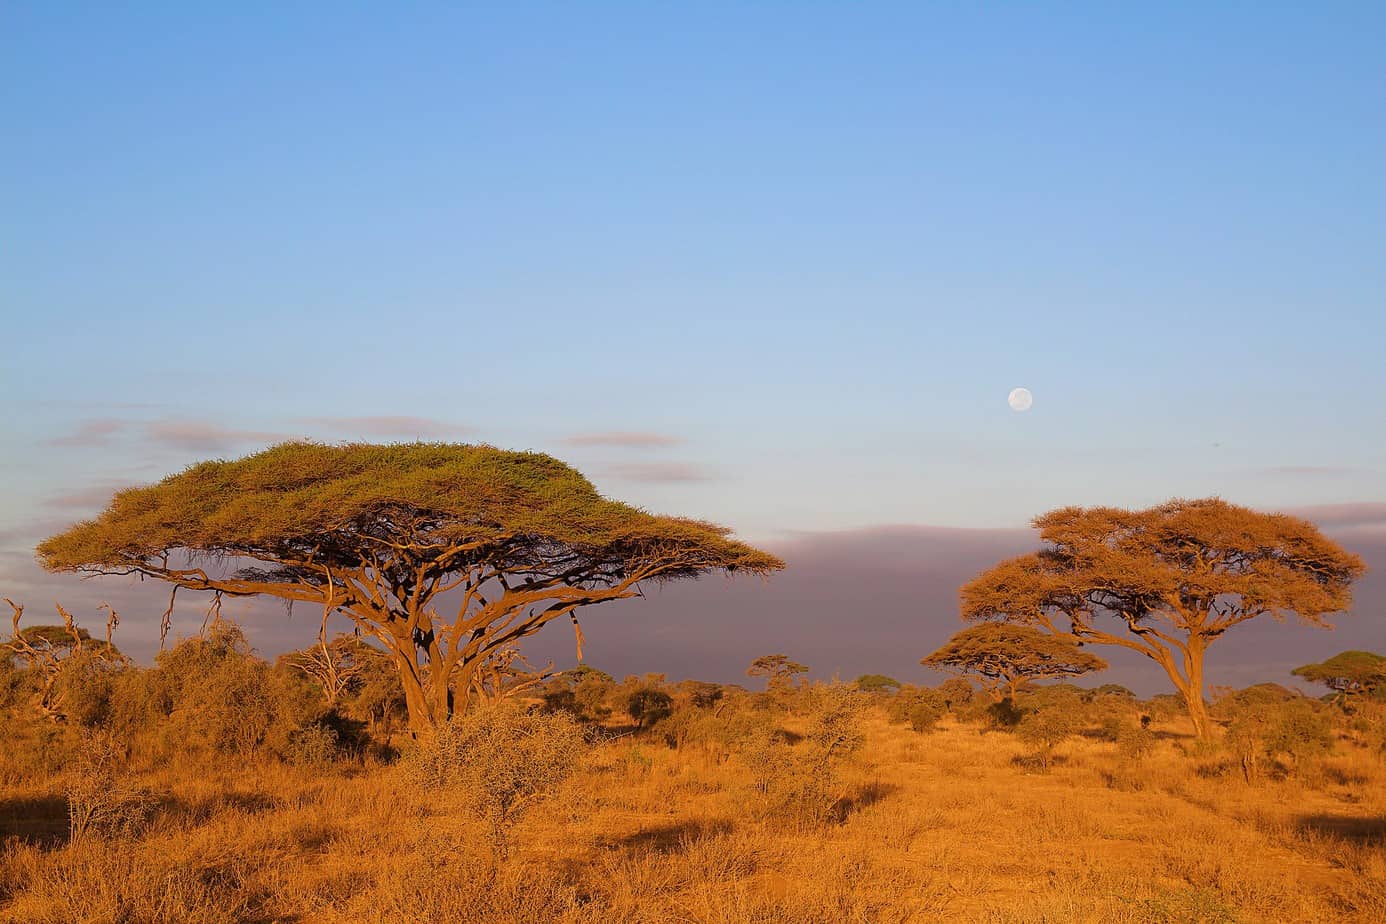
[962,499,1365,738]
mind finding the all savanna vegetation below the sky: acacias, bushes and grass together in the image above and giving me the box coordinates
[8,442,1386,924]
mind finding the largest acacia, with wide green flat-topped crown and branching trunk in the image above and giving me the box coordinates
[37,442,783,734]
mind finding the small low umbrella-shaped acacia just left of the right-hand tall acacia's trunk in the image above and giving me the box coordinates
[920,622,1107,702]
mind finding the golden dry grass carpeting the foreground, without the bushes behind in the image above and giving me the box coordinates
[0,715,1386,924]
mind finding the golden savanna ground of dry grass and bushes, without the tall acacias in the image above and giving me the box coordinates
[0,622,1386,924]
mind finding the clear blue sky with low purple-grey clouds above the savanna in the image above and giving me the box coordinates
[0,3,1386,692]
